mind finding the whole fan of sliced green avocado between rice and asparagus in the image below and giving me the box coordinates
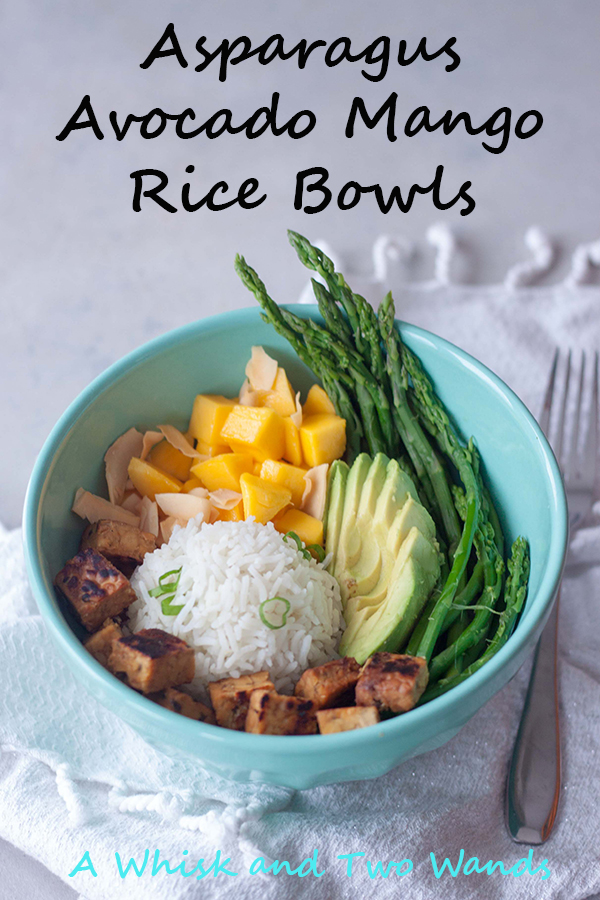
[327,453,440,662]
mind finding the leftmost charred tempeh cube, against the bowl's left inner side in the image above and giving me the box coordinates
[54,549,135,631]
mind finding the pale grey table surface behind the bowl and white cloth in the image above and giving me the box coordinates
[0,0,600,900]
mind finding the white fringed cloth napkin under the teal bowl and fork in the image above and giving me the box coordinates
[0,236,600,900]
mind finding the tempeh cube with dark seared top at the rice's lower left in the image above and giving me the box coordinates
[108,628,196,694]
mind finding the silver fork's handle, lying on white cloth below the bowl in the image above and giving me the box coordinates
[506,597,561,844]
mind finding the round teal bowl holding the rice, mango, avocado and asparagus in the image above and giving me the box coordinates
[24,306,567,789]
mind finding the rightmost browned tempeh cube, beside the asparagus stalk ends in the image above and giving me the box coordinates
[356,652,429,713]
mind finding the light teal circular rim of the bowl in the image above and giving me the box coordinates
[23,303,568,763]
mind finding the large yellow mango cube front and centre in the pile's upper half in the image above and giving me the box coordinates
[221,406,285,460]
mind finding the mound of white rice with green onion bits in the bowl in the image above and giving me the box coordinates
[129,518,344,693]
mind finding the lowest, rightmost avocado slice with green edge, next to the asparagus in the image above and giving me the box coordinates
[340,527,440,663]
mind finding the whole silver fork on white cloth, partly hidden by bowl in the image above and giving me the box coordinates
[506,350,599,844]
